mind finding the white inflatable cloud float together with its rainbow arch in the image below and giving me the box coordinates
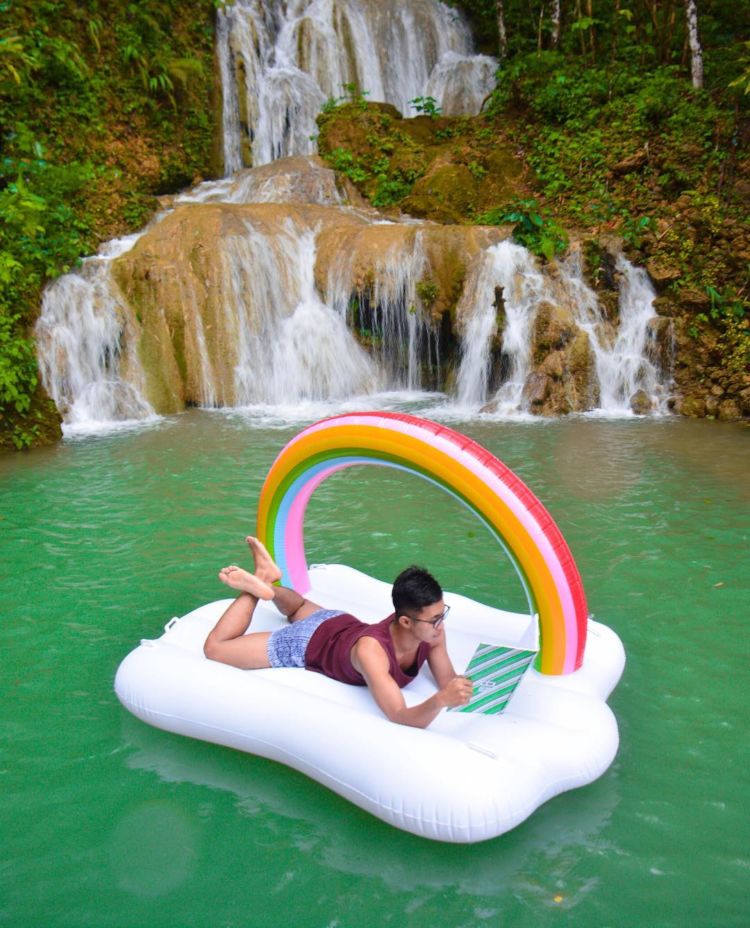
[115,413,625,842]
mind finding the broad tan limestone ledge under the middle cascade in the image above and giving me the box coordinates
[113,179,506,413]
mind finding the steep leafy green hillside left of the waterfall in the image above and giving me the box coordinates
[0,0,219,447]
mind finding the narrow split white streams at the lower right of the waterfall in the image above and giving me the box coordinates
[456,242,666,415]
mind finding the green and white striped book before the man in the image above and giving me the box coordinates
[448,644,537,715]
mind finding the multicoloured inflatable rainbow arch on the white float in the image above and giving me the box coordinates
[257,412,588,675]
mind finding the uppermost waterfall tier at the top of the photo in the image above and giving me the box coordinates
[217,0,497,173]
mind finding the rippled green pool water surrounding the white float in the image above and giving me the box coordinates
[0,412,750,928]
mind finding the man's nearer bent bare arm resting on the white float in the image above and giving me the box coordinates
[351,635,472,728]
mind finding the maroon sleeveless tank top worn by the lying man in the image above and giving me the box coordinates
[305,613,430,687]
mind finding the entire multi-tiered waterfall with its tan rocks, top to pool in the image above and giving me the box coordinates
[36,0,665,430]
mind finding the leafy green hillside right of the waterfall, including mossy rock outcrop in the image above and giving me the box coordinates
[319,0,750,419]
